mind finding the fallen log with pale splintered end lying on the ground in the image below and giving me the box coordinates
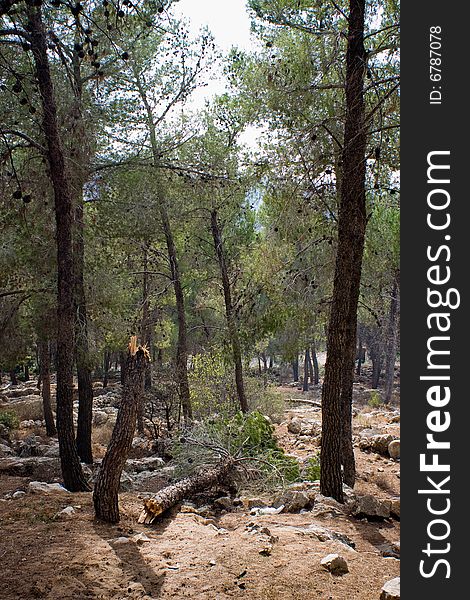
[139,458,234,525]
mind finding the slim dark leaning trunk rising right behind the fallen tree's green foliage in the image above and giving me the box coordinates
[211,210,248,413]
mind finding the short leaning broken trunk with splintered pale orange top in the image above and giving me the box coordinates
[93,342,148,523]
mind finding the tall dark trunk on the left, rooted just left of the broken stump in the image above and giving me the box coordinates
[28,7,89,492]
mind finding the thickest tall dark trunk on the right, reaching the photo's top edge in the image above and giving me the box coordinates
[320,0,367,502]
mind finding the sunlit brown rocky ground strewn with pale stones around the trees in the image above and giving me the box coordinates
[0,382,400,600]
